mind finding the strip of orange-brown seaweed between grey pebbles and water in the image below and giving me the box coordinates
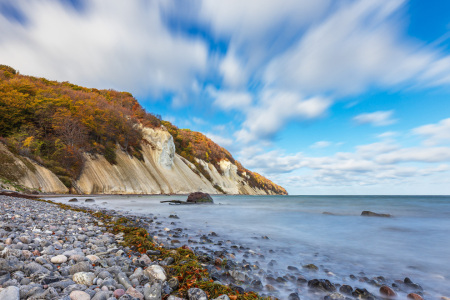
[30,199,269,300]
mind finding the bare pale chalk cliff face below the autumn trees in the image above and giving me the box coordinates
[0,128,282,195]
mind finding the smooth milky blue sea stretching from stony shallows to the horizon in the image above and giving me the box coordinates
[49,196,450,299]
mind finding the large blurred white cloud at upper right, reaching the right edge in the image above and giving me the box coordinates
[265,0,450,96]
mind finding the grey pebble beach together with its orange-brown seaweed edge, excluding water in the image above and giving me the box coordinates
[0,196,259,300]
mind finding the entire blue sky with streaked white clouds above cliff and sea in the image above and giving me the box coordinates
[0,0,450,195]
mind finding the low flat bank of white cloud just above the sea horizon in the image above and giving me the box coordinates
[240,137,450,193]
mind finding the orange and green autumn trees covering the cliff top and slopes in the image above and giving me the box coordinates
[0,65,286,194]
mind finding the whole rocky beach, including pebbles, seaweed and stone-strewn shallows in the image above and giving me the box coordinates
[0,196,440,300]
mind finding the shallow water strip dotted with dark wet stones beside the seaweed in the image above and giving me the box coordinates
[1,195,442,299]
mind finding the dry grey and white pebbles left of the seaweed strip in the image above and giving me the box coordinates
[0,196,211,300]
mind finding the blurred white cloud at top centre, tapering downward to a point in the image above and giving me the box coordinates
[199,0,331,78]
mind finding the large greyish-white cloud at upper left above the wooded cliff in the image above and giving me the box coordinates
[0,0,208,95]
